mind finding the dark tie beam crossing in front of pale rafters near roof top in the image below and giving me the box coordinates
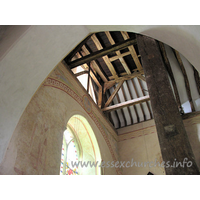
[67,36,136,69]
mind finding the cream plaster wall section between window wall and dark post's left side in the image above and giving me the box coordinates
[117,120,165,175]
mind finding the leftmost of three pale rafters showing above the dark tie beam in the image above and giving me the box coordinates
[91,34,118,78]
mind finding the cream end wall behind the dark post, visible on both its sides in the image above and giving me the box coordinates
[117,115,200,175]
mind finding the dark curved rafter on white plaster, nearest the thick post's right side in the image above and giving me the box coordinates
[158,42,181,109]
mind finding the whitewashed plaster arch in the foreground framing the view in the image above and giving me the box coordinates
[0,25,200,162]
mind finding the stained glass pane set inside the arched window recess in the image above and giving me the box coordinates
[60,129,79,175]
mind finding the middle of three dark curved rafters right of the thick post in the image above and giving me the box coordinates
[173,49,195,112]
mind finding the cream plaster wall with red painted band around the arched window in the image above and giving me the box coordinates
[0,64,121,175]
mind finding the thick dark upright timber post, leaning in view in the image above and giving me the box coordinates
[137,35,199,175]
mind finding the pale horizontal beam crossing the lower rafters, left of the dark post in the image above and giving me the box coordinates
[102,95,150,112]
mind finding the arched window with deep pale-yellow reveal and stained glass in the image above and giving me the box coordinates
[60,115,101,175]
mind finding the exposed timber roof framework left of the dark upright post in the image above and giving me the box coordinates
[65,31,152,127]
